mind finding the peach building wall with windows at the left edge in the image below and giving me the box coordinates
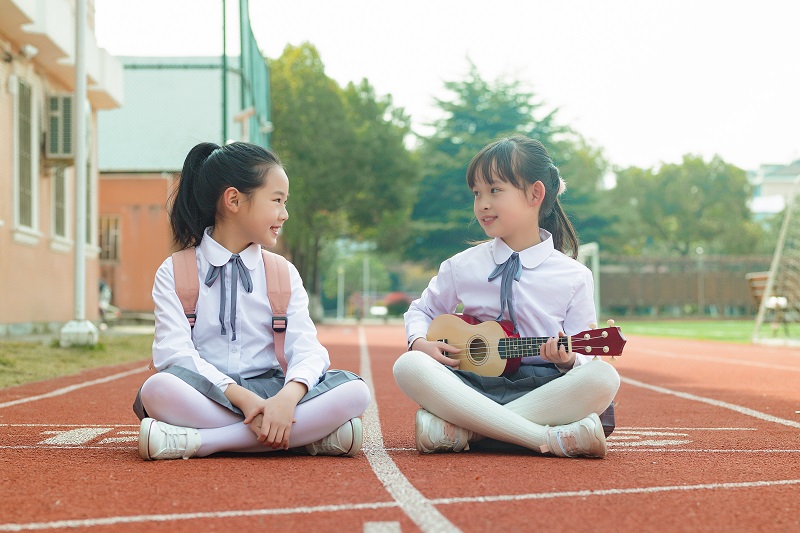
[0,0,122,335]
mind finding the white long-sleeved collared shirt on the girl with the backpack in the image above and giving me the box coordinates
[153,229,330,391]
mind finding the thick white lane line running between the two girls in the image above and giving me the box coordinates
[358,327,460,532]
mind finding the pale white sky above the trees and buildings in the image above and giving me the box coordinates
[95,0,800,169]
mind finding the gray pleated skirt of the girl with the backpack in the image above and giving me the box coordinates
[133,366,361,420]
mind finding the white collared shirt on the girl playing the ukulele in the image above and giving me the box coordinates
[404,229,597,366]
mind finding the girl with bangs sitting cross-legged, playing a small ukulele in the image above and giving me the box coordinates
[394,135,620,457]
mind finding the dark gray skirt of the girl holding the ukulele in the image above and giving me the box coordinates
[447,363,564,405]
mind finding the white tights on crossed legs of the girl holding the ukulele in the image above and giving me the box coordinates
[394,351,619,451]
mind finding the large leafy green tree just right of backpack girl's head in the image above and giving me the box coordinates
[270,43,418,296]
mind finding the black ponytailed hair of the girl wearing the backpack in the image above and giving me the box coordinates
[169,142,281,249]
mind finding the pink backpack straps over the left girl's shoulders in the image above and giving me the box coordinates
[160,248,292,374]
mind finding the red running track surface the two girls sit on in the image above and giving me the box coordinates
[0,326,800,533]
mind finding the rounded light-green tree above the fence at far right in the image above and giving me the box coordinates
[614,155,763,256]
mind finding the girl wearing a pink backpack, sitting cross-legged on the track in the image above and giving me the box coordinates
[134,142,370,460]
